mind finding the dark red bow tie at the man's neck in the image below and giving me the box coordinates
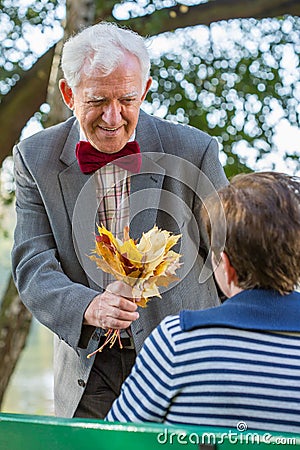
[76,141,142,173]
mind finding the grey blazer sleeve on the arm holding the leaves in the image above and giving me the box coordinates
[12,146,99,349]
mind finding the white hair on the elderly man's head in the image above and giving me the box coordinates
[61,22,150,89]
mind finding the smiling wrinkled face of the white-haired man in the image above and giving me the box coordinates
[60,54,151,153]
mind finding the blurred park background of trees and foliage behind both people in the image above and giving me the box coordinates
[0,0,300,415]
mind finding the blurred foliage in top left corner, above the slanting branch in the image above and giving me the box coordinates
[0,0,65,99]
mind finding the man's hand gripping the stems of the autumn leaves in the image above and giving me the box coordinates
[84,281,139,330]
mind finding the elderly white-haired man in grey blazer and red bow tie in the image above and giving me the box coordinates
[12,22,226,418]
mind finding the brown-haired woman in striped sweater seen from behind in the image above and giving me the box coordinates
[107,172,300,433]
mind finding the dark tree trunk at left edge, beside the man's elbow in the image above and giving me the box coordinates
[0,277,31,408]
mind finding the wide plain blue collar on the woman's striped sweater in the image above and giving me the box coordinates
[180,289,300,332]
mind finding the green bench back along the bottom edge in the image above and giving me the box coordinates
[0,413,300,450]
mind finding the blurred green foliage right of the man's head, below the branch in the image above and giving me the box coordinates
[148,17,300,176]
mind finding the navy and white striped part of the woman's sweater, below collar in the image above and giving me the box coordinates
[107,295,300,433]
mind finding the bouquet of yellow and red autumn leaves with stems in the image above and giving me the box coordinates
[88,225,181,357]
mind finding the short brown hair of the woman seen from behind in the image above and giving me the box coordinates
[203,172,300,294]
